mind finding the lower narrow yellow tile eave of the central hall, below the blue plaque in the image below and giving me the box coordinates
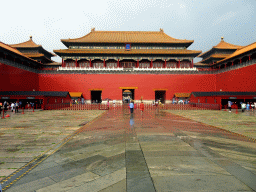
[53,49,202,54]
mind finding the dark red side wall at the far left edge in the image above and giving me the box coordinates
[0,63,38,91]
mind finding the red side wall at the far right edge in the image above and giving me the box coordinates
[216,64,256,92]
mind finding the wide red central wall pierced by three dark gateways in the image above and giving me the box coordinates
[39,74,216,100]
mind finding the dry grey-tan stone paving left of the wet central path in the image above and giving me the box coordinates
[0,110,104,181]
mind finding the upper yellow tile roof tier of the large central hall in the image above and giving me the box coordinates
[61,29,194,43]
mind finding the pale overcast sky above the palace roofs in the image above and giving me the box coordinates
[0,0,256,62]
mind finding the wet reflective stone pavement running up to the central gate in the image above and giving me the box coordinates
[2,109,256,192]
